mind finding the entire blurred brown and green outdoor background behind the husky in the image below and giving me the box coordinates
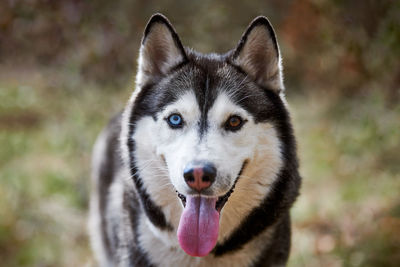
[0,0,400,267]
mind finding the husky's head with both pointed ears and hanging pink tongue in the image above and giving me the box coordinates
[122,15,287,256]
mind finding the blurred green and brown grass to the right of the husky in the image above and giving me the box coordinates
[290,88,400,267]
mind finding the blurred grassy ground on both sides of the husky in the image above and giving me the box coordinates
[0,65,400,266]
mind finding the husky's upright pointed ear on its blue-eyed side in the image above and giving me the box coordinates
[136,14,187,86]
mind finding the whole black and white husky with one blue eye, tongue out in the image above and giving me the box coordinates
[90,14,301,266]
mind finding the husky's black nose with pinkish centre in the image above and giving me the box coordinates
[183,161,217,192]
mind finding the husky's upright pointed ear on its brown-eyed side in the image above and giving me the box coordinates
[232,16,284,93]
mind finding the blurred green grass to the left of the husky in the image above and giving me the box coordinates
[0,70,124,266]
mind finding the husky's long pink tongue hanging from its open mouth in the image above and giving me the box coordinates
[178,196,219,257]
